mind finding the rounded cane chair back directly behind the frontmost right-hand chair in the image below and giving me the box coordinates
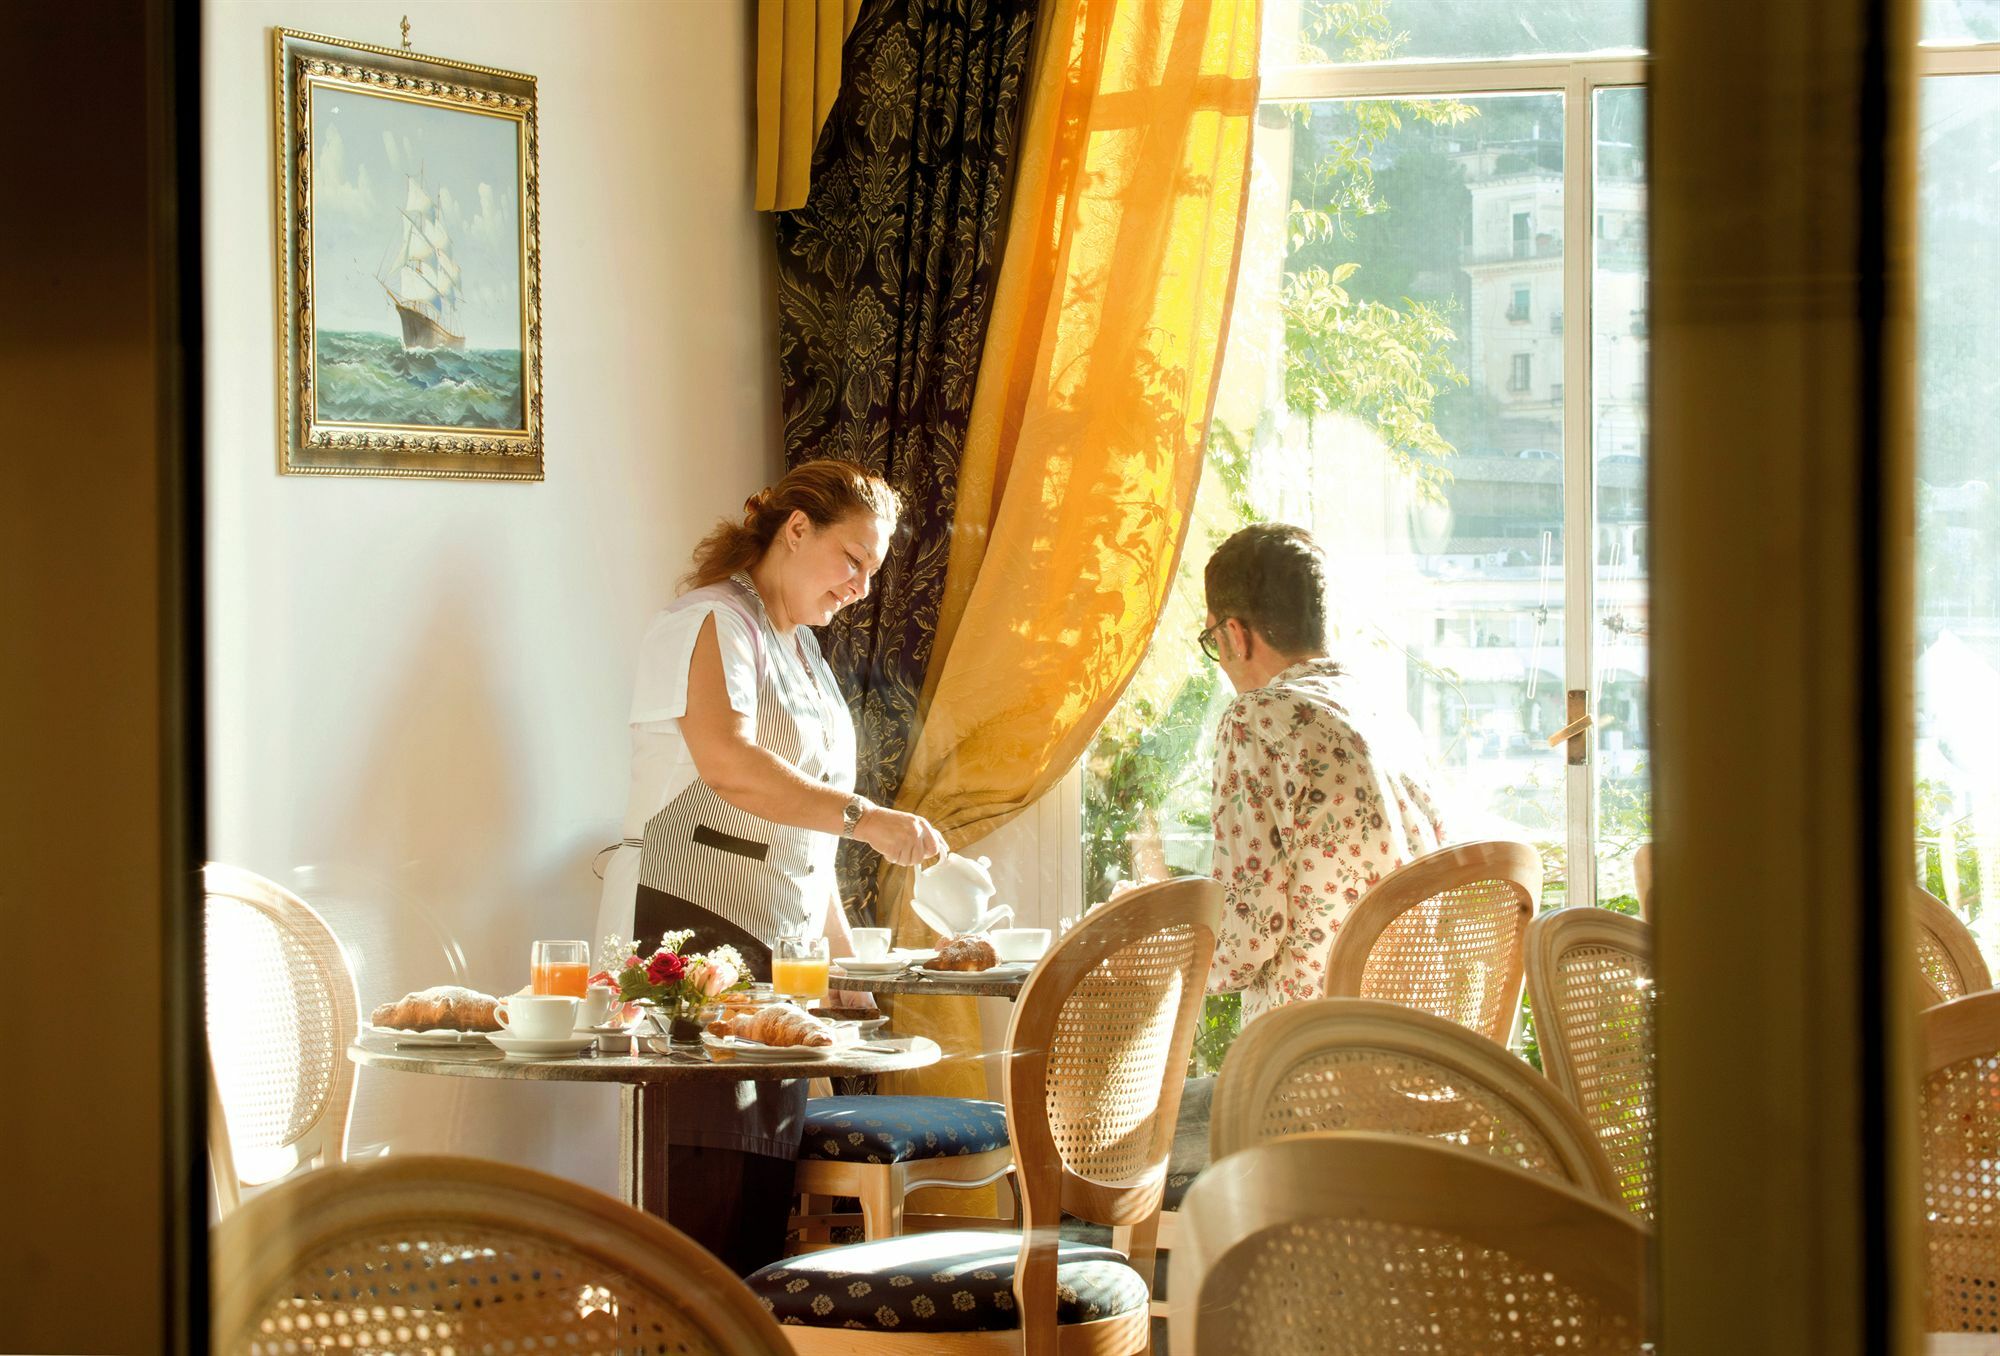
[1208,998,1616,1200]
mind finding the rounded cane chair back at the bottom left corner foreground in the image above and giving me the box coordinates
[214,1158,788,1356]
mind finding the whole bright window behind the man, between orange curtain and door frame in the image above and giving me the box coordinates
[1084,0,1648,1066]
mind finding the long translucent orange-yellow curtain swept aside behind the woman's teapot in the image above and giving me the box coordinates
[884,0,1258,1176]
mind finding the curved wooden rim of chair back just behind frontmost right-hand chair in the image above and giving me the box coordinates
[1190,998,1618,1200]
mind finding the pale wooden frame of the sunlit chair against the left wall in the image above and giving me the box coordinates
[202,862,360,1214]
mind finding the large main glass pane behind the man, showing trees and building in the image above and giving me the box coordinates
[1084,94,1564,1062]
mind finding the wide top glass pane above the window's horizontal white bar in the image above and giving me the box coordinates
[1264,0,1640,66]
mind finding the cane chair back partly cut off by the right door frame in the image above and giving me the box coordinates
[1528,906,1658,1220]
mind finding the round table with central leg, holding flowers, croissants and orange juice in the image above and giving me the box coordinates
[348,1036,940,1220]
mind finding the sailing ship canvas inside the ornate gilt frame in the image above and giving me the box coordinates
[312,86,528,436]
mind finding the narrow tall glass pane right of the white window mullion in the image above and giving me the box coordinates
[1590,88,1652,914]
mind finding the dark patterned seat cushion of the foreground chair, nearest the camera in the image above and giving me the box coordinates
[748,1230,1150,1332]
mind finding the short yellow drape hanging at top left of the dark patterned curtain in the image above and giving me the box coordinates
[756,0,862,212]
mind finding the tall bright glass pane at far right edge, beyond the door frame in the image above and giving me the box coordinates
[1916,76,2000,954]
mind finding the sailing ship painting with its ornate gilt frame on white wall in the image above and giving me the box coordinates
[272,28,542,480]
